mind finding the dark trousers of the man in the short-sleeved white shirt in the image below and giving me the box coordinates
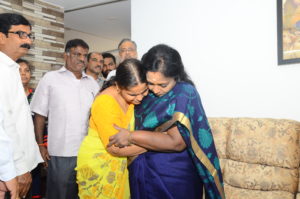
[46,156,79,199]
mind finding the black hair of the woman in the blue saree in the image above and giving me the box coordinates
[142,44,194,85]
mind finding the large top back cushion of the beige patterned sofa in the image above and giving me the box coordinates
[227,118,300,168]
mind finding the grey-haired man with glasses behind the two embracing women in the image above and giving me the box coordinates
[106,38,138,80]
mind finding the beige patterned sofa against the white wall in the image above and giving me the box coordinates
[209,118,300,199]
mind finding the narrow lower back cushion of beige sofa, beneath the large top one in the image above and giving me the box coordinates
[223,160,299,193]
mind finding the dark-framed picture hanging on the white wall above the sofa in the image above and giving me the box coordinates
[277,0,300,65]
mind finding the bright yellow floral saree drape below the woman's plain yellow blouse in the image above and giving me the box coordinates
[76,128,130,199]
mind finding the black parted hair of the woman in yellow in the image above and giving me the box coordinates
[101,59,147,91]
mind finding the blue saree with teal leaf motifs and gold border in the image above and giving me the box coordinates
[128,83,225,199]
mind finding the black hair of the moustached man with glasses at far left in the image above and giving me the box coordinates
[0,13,31,35]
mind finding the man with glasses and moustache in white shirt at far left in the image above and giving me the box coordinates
[0,13,43,197]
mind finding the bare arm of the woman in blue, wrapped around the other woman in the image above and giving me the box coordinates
[108,126,186,152]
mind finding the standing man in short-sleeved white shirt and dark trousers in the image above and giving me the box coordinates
[31,39,99,199]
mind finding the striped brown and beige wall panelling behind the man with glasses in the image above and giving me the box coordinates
[0,0,65,86]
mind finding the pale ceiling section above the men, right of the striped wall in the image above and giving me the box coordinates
[45,0,131,42]
